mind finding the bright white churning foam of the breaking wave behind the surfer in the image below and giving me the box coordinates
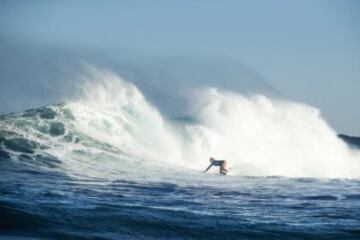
[54,69,360,178]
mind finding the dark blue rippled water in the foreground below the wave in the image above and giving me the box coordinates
[0,156,360,239]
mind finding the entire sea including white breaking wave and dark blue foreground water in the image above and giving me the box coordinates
[0,71,360,239]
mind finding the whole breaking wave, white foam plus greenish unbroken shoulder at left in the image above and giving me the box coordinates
[0,66,360,179]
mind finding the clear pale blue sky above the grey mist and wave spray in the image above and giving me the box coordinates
[0,0,360,135]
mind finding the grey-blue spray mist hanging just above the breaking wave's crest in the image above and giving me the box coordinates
[0,36,276,116]
